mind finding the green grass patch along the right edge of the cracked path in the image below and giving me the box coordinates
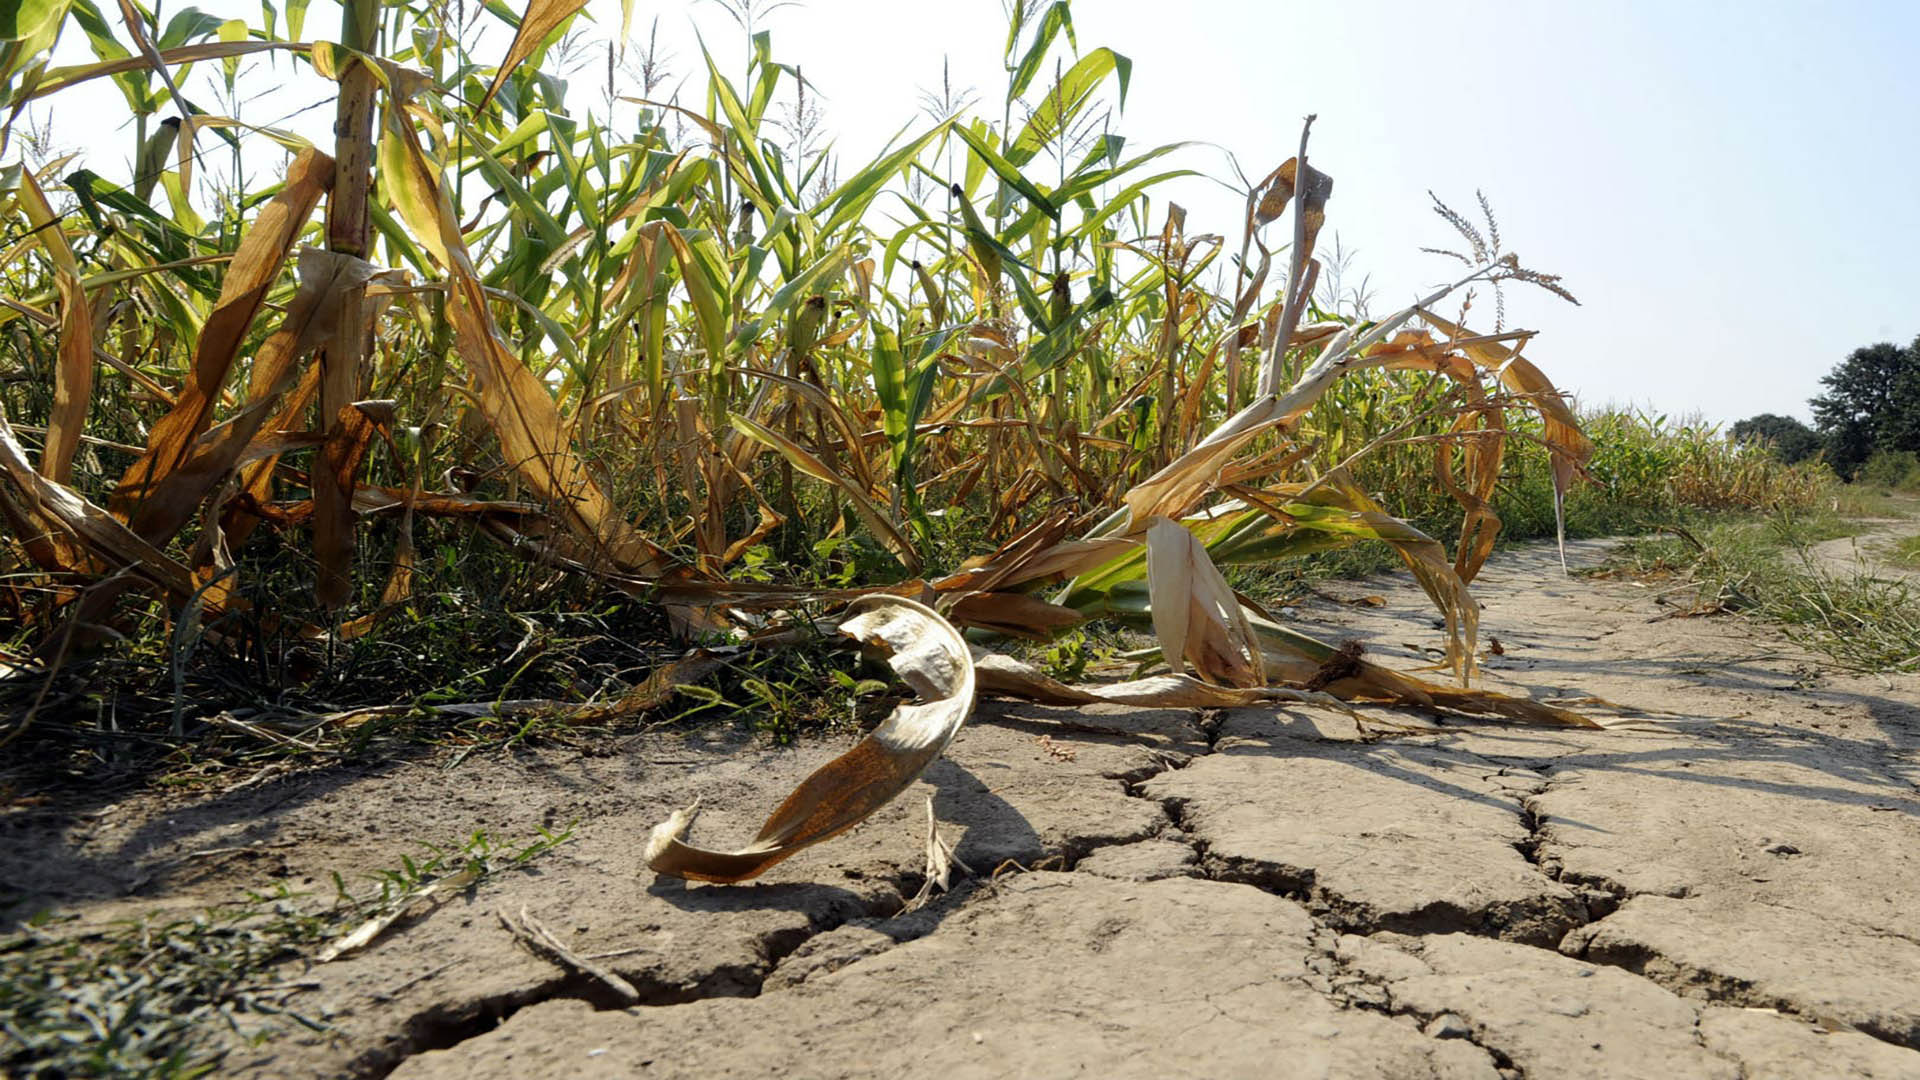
[1607,509,1920,673]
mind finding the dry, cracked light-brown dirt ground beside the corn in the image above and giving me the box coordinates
[0,542,1920,1080]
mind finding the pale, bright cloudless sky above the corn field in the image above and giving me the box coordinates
[30,0,1920,423]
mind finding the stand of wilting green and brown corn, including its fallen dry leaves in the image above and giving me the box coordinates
[0,0,1594,868]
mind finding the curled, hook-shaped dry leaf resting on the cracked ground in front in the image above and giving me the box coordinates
[647,596,973,882]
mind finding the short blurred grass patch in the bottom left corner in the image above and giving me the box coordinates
[0,826,572,1080]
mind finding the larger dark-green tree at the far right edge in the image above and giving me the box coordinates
[1811,338,1920,477]
